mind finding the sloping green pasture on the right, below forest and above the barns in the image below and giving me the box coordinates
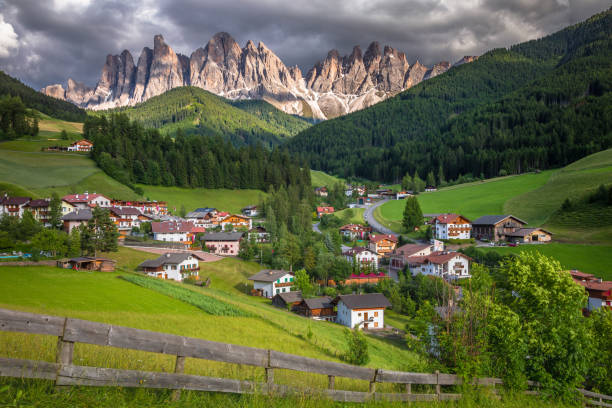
[374,149,612,244]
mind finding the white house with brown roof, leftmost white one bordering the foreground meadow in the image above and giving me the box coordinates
[138,252,204,282]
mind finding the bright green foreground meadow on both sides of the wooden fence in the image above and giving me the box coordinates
[0,253,572,408]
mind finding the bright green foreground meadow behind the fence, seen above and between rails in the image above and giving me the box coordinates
[0,248,428,390]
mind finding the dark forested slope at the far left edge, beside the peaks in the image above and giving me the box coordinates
[0,71,87,122]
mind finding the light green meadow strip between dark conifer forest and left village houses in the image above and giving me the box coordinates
[139,184,266,213]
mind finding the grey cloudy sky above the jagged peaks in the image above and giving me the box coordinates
[0,0,610,88]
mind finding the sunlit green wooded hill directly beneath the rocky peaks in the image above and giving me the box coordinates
[106,86,310,147]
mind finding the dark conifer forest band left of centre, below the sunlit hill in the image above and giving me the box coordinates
[83,114,311,194]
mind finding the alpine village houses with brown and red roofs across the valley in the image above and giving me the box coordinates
[0,182,612,331]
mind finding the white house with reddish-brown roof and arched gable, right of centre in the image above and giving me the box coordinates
[406,251,471,280]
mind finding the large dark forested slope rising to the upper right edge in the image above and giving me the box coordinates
[287,10,612,181]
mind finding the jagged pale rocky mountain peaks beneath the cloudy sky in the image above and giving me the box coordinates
[41,32,477,119]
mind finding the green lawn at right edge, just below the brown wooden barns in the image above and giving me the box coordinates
[482,242,612,280]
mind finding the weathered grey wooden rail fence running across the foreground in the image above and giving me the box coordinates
[0,309,612,407]
